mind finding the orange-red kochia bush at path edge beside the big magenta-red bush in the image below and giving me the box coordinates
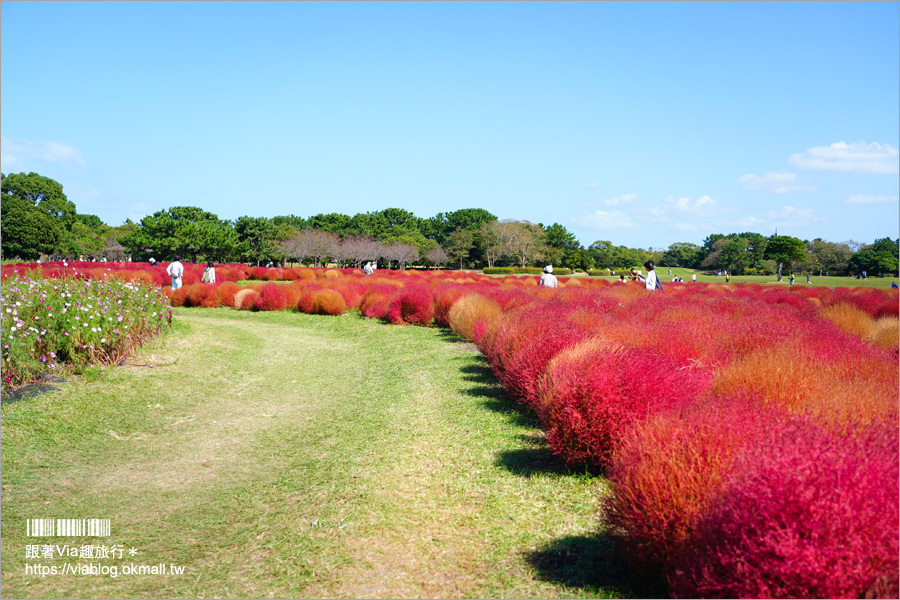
[603,394,787,575]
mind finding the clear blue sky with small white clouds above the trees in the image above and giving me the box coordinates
[0,1,900,248]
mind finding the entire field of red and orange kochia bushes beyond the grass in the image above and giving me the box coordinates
[3,263,900,598]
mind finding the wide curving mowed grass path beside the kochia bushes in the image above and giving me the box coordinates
[0,309,646,598]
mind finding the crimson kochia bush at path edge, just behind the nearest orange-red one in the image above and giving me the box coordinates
[538,339,711,468]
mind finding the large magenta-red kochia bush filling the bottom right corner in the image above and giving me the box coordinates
[670,422,900,598]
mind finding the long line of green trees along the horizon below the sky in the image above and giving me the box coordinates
[0,173,900,275]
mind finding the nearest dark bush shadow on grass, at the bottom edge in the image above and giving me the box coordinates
[525,534,669,598]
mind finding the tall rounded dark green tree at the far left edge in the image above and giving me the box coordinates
[0,173,75,260]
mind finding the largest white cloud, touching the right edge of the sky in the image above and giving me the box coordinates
[788,142,900,175]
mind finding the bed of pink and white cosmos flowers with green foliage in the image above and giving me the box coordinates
[0,272,172,388]
